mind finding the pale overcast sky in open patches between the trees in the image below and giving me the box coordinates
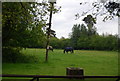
[44,0,118,38]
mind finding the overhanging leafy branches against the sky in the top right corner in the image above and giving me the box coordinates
[75,0,120,22]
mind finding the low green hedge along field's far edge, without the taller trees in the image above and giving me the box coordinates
[50,35,118,51]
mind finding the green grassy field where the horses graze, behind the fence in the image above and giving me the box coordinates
[2,49,118,76]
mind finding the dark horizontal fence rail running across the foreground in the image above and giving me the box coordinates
[0,74,120,81]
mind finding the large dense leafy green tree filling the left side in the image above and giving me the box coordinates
[2,2,47,61]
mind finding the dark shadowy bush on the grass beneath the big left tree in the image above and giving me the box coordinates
[2,47,38,63]
